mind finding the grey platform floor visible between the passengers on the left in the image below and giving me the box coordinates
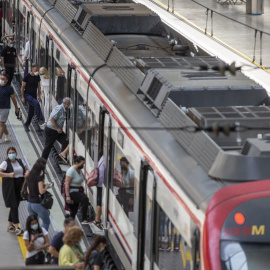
[0,83,94,269]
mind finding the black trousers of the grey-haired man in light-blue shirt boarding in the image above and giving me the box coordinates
[41,127,68,159]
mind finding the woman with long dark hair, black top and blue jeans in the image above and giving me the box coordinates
[26,158,51,231]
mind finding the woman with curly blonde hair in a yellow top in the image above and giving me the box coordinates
[58,226,84,270]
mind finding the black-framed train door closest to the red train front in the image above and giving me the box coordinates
[137,161,156,270]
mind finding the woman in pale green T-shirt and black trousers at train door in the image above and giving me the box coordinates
[65,156,89,224]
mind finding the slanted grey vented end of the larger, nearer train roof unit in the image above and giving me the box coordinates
[137,69,173,115]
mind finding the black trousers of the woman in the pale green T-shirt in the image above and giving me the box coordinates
[69,192,89,220]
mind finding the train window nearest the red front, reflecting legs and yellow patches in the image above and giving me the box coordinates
[158,208,187,270]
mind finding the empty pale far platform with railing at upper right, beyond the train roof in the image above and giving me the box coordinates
[135,0,270,93]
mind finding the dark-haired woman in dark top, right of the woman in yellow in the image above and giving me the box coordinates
[84,235,107,270]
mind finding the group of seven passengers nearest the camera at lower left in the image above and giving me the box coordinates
[0,147,107,270]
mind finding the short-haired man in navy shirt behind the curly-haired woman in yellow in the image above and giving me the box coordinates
[49,215,75,265]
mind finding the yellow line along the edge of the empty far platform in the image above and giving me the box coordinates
[150,0,270,73]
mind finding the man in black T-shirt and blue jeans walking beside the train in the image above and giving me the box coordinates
[21,65,44,131]
